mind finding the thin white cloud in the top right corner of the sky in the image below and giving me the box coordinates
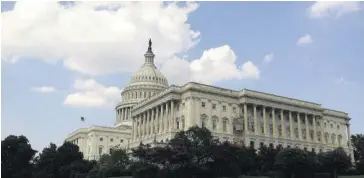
[308,1,360,19]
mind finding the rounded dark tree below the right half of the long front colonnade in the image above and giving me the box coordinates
[274,148,314,178]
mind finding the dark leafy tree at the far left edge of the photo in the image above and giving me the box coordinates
[1,135,37,178]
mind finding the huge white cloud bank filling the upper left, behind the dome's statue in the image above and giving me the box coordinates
[1,1,199,75]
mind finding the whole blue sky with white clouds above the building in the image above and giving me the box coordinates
[1,1,364,150]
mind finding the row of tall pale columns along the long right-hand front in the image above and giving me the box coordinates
[244,103,323,142]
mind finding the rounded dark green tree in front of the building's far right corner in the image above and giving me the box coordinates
[318,148,351,178]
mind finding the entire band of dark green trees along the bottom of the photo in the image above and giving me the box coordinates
[1,129,364,178]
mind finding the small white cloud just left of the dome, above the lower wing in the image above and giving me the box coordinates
[64,79,121,107]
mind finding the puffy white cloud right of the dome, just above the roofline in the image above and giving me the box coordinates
[161,45,260,84]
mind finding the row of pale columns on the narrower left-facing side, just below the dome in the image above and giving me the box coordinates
[133,100,177,141]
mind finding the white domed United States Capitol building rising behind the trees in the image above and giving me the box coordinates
[66,41,353,159]
